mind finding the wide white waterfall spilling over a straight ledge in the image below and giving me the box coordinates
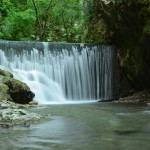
[0,41,114,103]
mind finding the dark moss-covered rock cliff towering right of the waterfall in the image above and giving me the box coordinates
[88,0,150,88]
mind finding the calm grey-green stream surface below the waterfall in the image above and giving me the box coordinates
[0,102,150,150]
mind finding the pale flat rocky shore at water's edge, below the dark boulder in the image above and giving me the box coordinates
[0,101,49,128]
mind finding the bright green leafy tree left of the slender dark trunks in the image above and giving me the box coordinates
[0,0,35,40]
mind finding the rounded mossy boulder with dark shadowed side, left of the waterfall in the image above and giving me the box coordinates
[0,69,35,104]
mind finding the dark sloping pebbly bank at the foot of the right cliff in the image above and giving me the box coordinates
[113,90,150,105]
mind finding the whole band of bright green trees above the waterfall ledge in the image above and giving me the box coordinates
[0,0,88,42]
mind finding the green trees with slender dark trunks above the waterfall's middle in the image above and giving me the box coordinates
[32,0,86,42]
